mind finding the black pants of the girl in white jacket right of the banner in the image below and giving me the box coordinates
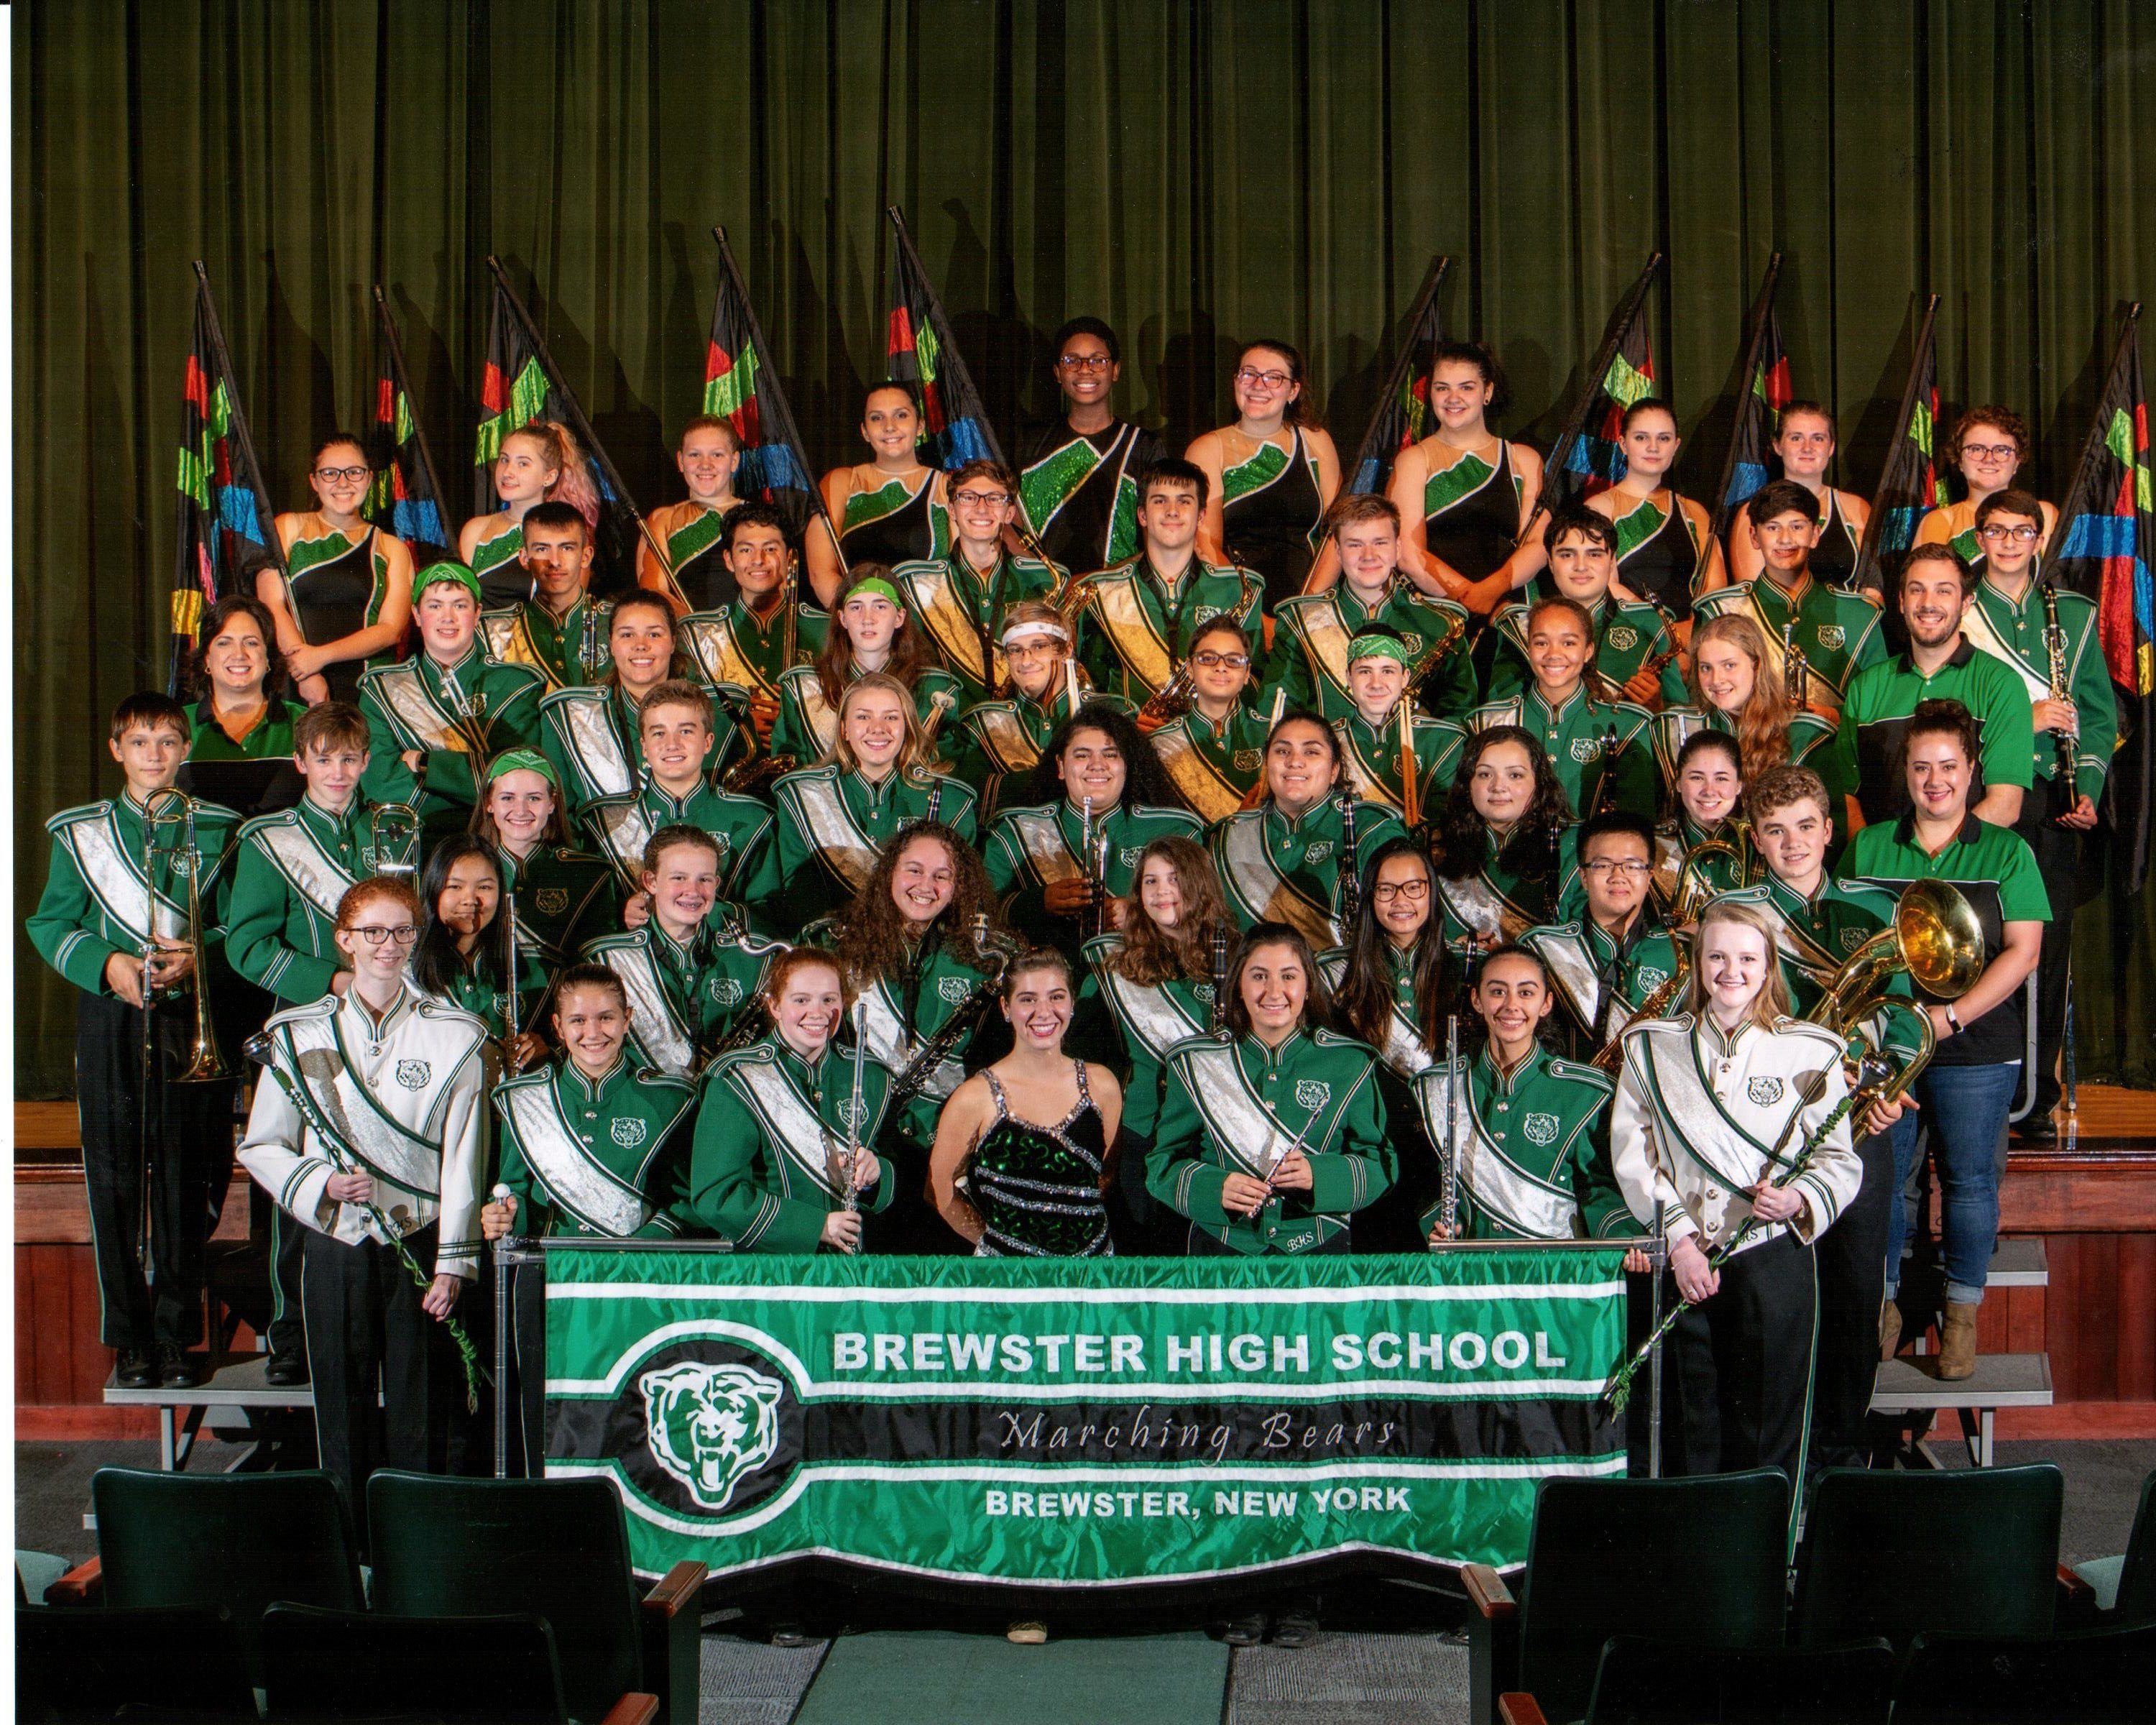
[1671,1233,1818,1486]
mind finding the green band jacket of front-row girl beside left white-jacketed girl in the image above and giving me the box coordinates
[494,1054,696,1240]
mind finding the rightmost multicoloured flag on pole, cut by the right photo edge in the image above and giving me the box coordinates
[2046,302,2156,893]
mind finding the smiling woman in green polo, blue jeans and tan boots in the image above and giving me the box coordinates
[1835,701,2050,1378]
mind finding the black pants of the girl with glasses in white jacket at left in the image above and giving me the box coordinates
[302,1225,464,1529]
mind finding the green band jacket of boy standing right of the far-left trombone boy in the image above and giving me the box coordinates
[224,796,405,1007]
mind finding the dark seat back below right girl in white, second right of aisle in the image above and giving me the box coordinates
[1789,1462,2065,1647]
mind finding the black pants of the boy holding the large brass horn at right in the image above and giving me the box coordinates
[1811,1132,1895,1468]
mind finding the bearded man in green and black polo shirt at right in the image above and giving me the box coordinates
[1835,546,2035,830]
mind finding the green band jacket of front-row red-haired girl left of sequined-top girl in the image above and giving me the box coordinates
[688,1035,897,1253]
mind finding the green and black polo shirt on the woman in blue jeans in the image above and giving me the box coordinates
[1835,811,2050,1065]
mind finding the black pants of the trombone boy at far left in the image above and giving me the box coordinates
[75,994,233,1348]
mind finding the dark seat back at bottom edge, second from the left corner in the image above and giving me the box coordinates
[263,1604,658,1725]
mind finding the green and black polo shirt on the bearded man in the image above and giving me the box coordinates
[1835,636,2035,822]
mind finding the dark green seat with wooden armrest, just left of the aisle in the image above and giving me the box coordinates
[367,1471,705,1725]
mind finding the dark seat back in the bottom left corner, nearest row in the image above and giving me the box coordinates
[15,1604,257,1725]
